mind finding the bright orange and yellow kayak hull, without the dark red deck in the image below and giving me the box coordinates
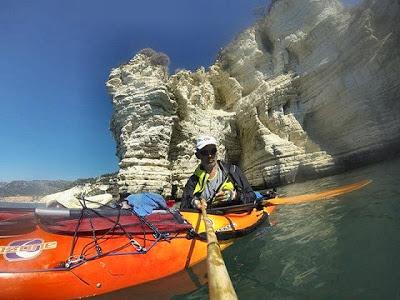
[0,206,274,299]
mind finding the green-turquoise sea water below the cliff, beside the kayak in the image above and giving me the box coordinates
[174,159,400,299]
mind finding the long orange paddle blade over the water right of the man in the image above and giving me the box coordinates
[263,179,372,205]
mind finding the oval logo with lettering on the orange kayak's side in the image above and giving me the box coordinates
[0,239,57,261]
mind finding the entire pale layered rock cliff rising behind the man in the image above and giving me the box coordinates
[107,0,400,194]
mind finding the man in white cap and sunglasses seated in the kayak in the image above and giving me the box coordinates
[181,136,256,209]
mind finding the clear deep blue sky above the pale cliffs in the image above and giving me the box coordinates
[0,0,358,181]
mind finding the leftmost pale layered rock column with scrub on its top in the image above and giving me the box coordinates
[107,53,176,191]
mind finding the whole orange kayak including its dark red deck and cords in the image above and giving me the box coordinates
[0,205,275,299]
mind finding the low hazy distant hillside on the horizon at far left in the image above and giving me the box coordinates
[0,180,74,197]
